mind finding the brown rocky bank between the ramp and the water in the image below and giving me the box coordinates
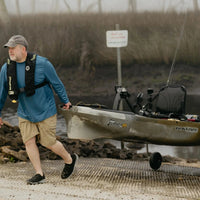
[0,121,200,167]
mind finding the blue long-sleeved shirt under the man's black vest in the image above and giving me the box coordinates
[0,56,69,122]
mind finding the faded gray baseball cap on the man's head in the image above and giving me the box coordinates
[4,35,28,48]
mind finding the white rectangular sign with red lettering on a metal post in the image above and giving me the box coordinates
[106,30,128,48]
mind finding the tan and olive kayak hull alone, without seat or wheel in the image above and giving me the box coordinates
[59,106,200,146]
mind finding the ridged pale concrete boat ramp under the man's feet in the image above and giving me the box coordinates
[0,158,200,200]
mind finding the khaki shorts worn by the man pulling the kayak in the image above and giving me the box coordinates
[19,114,57,147]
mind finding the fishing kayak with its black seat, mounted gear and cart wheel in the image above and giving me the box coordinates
[59,85,200,170]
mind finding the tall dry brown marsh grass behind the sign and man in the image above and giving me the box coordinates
[0,12,200,69]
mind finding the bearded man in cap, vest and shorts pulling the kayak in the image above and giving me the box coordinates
[0,35,78,184]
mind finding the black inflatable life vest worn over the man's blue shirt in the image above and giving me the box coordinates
[7,53,47,103]
